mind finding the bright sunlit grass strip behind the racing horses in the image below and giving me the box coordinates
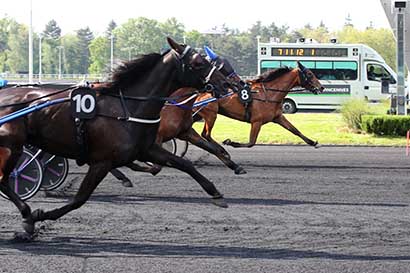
[194,113,406,146]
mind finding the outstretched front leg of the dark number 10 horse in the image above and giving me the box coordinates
[144,144,228,208]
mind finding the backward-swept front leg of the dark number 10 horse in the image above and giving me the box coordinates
[31,162,112,222]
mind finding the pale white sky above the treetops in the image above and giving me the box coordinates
[0,0,389,34]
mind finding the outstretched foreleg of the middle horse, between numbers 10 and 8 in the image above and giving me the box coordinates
[180,128,246,174]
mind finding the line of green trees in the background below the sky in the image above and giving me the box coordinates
[0,17,396,75]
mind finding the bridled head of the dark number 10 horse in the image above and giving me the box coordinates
[167,37,233,97]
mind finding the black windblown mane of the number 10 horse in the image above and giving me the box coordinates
[111,53,163,87]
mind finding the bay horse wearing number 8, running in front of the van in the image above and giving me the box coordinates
[197,62,324,152]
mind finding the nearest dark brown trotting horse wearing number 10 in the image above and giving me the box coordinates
[0,38,232,239]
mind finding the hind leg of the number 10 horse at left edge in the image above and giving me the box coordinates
[0,147,34,236]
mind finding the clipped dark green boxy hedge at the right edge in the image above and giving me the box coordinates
[362,115,410,136]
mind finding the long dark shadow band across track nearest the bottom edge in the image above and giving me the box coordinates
[0,237,410,261]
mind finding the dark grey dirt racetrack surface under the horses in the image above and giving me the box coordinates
[0,143,410,273]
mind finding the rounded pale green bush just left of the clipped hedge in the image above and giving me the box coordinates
[340,98,370,131]
